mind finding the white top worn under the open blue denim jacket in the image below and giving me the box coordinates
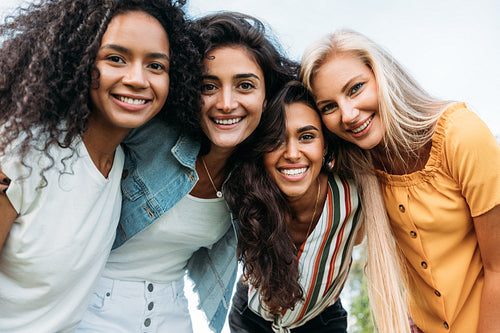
[103,194,231,283]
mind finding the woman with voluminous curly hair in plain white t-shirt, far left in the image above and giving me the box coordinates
[0,0,199,332]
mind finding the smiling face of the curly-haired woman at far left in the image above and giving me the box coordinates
[90,11,170,134]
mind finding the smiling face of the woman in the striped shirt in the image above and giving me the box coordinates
[264,102,326,200]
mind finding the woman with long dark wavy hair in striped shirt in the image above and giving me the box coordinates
[226,82,408,333]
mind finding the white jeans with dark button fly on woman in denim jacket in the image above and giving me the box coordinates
[75,277,193,333]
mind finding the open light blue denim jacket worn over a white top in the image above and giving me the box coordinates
[113,119,237,332]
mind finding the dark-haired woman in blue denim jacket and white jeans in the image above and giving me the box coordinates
[78,13,297,333]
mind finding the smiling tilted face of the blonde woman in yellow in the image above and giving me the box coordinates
[311,54,385,149]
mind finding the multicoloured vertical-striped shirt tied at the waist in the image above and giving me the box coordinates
[248,175,361,333]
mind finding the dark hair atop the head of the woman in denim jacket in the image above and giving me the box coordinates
[191,12,299,156]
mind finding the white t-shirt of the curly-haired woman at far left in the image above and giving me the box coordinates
[0,139,124,333]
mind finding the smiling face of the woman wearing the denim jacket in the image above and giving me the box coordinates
[200,46,265,151]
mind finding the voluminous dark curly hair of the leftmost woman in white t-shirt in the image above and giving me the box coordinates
[0,0,201,175]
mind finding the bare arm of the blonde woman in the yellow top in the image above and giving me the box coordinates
[473,206,500,333]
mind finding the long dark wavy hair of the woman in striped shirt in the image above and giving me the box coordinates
[224,81,331,313]
